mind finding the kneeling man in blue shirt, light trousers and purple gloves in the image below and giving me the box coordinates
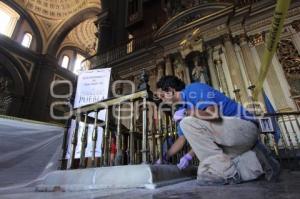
[157,76,279,185]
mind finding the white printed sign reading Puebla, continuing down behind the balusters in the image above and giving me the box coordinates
[66,68,111,159]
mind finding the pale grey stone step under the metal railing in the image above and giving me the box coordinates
[36,165,197,191]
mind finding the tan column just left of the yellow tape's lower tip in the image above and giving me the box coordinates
[224,34,248,102]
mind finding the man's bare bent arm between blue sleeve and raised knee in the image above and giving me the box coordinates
[186,105,222,121]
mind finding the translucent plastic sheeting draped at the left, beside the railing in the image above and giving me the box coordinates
[0,116,64,191]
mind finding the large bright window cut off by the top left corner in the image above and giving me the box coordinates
[0,2,20,37]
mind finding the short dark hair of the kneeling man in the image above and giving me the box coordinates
[156,75,185,91]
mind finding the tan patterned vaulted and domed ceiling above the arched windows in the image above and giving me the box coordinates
[15,0,101,53]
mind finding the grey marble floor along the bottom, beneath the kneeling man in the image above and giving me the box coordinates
[0,171,300,199]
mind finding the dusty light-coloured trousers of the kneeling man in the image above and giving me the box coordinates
[180,117,263,181]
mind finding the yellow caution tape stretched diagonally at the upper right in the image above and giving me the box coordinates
[253,0,291,100]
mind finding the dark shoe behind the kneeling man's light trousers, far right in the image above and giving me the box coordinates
[253,141,280,182]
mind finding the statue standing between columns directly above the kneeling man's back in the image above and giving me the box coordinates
[192,56,209,84]
